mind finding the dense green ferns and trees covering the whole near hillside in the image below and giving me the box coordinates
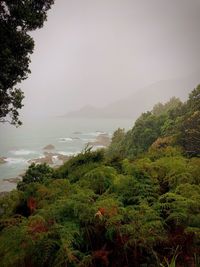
[0,86,200,267]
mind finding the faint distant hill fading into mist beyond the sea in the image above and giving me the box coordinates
[64,74,200,119]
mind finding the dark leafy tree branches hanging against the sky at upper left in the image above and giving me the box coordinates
[0,0,54,126]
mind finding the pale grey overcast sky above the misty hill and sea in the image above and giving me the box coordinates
[20,0,200,118]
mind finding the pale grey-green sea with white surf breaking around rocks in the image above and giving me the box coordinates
[0,118,133,192]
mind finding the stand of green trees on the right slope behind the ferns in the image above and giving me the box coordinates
[107,86,200,160]
